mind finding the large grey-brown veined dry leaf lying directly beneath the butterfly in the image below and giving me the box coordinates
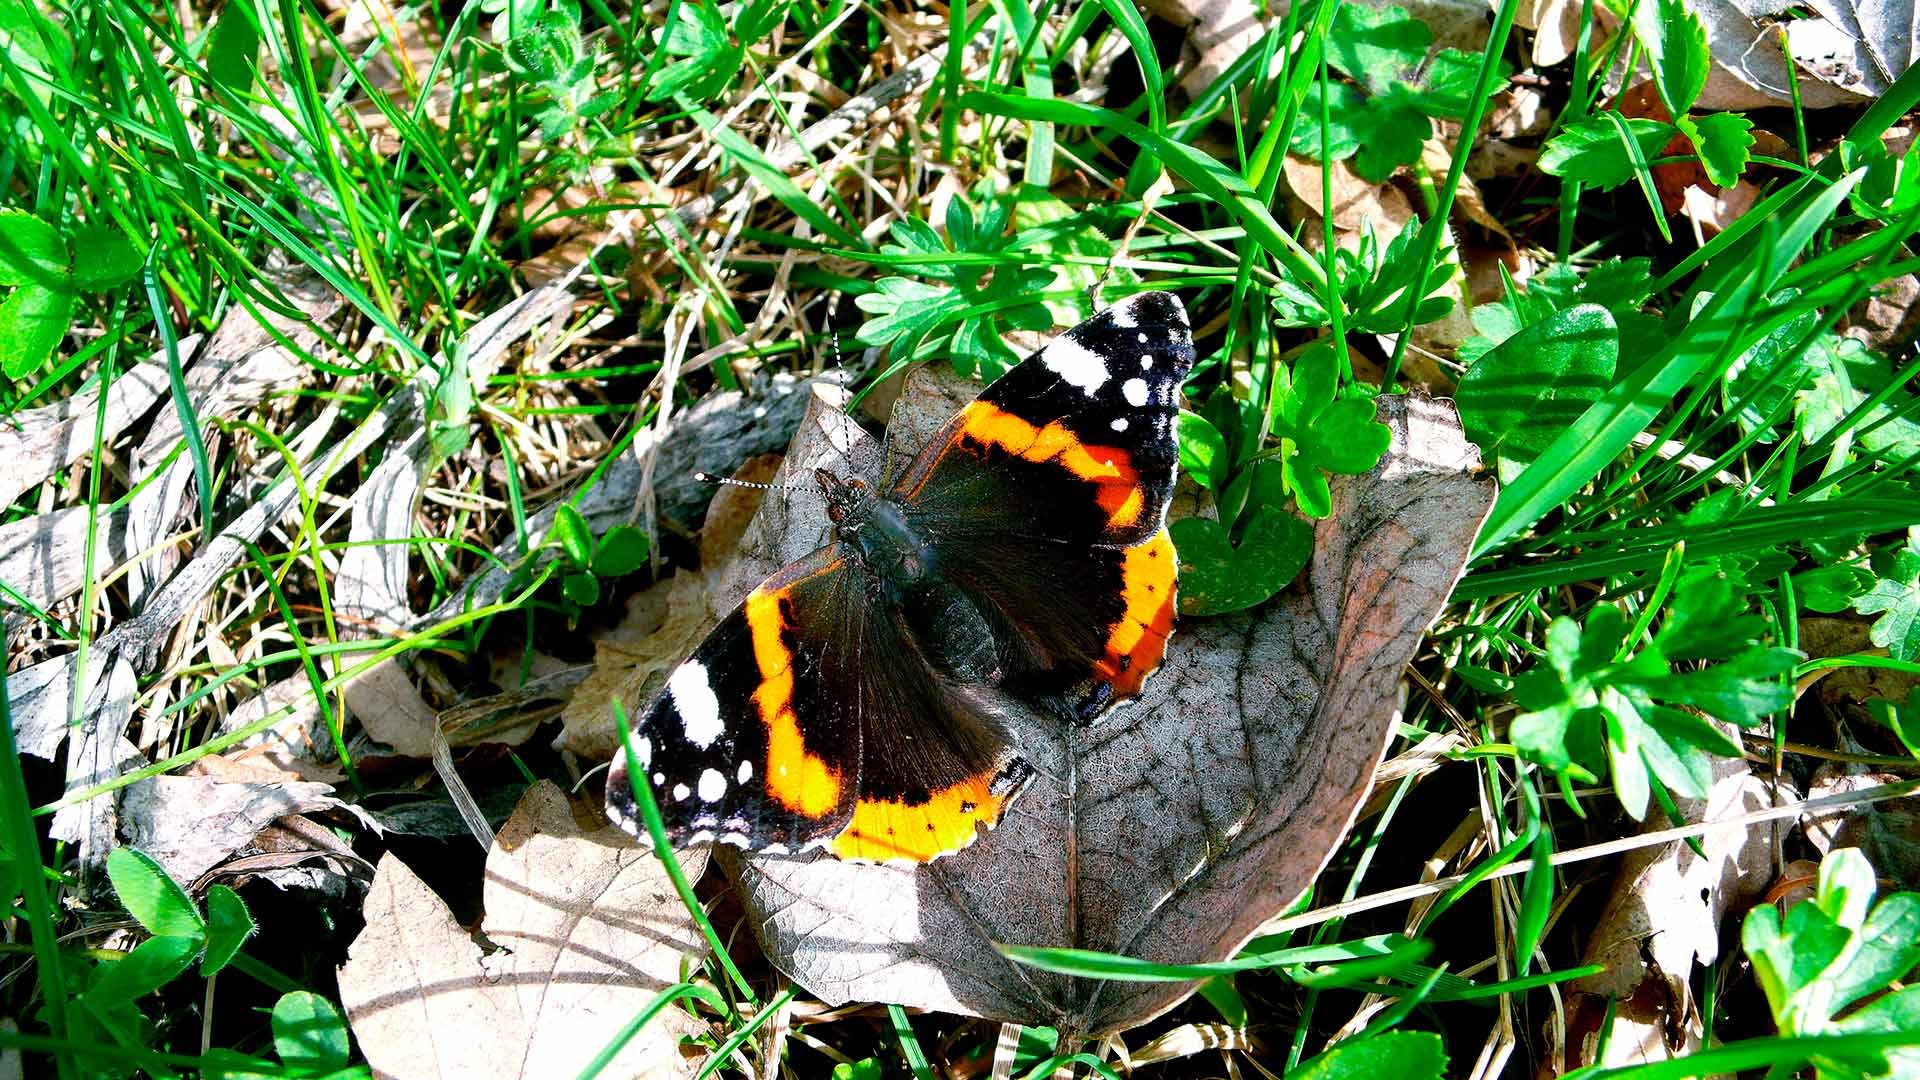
[691,365,1492,1034]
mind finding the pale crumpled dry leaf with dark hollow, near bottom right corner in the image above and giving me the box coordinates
[1546,745,1774,1074]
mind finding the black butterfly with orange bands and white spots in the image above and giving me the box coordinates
[607,292,1194,863]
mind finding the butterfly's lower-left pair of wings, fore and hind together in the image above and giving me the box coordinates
[609,546,1031,863]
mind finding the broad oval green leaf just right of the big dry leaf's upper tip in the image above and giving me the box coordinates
[1455,304,1620,461]
